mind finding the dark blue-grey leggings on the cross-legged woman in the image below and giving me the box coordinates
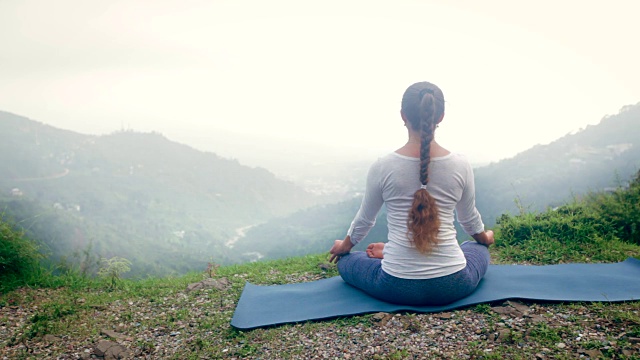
[338,241,489,306]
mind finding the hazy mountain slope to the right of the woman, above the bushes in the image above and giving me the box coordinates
[475,103,640,225]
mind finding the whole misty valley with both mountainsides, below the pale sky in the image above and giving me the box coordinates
[0,104,640,277]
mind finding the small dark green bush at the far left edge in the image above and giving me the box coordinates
[0,215,42,293]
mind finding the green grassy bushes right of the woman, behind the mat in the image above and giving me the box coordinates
[496,172,640,264]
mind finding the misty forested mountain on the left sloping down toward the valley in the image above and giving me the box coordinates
[0,112,318,274]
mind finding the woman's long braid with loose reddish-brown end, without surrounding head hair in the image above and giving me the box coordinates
[407,88,440,253]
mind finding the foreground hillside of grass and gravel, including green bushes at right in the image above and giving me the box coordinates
[0,172,640,359]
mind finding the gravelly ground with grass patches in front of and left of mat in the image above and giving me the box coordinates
[0,268,640,359]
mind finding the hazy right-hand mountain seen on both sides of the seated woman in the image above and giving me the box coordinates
[231,103,640,260]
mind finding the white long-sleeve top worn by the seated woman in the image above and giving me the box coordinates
[347,152,484,279]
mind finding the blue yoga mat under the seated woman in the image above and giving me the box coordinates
[231,258,640,329]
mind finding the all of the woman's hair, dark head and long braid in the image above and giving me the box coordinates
[401,82,444,254]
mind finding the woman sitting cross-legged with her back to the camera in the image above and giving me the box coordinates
[330,82,494,305]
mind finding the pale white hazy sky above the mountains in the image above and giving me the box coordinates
[0,0,640,167]
